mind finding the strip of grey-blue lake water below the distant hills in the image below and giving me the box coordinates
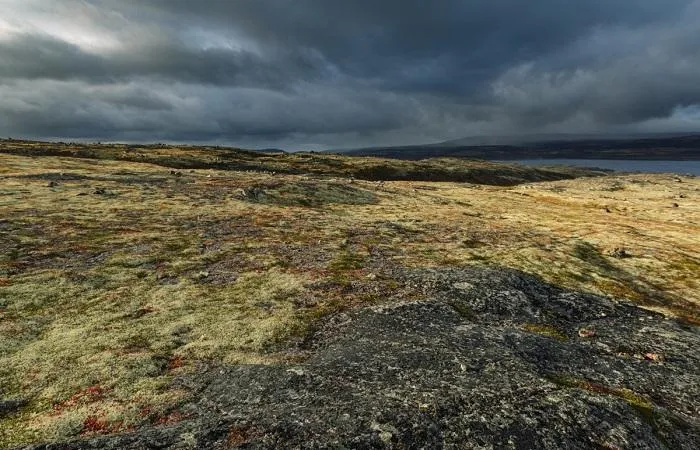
[503,159,700,176]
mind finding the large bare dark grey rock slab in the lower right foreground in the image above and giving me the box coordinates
[21,267,700,449]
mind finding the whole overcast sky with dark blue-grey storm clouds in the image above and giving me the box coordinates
[0,0,700,149]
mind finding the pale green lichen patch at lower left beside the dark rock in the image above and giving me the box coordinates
[0,270,304,444]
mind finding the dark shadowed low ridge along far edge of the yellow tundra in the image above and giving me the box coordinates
[0,140,599,186]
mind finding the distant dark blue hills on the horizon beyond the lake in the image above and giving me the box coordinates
[337,133,700,161]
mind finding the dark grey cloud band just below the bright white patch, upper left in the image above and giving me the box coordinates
[0,34,328,89]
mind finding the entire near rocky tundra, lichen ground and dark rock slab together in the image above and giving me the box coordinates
[0,141,700,449]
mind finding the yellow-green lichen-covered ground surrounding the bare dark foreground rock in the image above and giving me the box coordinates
[0,141,700,447]
